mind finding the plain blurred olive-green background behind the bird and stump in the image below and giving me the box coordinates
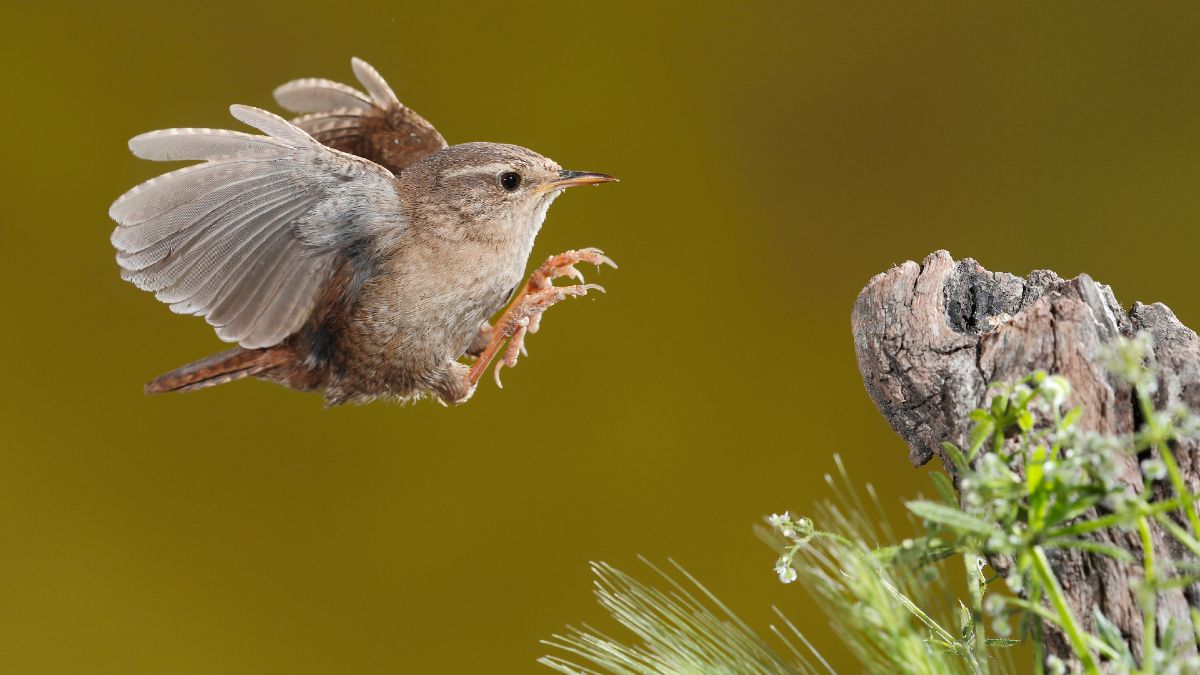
[0,0,1200,674]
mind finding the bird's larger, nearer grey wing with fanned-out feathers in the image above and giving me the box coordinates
[108,106,407,348]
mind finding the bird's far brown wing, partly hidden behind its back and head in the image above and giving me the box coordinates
[275,59,446,173]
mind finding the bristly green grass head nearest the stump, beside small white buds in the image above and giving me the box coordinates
[757,455,1019,675]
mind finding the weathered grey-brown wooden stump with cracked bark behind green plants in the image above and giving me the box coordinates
[851,251,1200,658]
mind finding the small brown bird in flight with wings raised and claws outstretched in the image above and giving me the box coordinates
[109,58,617,406]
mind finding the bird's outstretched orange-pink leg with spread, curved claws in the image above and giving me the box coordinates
[467,249,617,387]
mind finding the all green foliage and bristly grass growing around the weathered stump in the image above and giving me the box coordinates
[542,336,1200,675]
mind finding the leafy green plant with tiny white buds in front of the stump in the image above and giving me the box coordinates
[768,336,1200,674]
